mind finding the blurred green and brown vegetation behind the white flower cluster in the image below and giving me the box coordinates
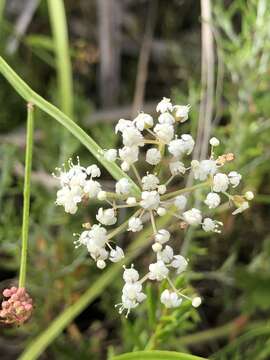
[0,0,270,360]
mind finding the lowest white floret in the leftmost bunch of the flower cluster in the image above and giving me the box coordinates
[55,186,82,214]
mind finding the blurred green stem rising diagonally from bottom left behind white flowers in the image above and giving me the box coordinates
[19,215,170,360]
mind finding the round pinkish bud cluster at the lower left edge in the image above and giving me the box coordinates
[0,286,33,325]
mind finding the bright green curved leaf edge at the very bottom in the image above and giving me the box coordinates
[112,350,208,360]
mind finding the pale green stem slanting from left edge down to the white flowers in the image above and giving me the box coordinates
[0,56,141,197]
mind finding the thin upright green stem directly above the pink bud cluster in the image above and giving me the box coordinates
[19,103,34,287]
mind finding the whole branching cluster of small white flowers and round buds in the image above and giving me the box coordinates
[53,98,253,314]
